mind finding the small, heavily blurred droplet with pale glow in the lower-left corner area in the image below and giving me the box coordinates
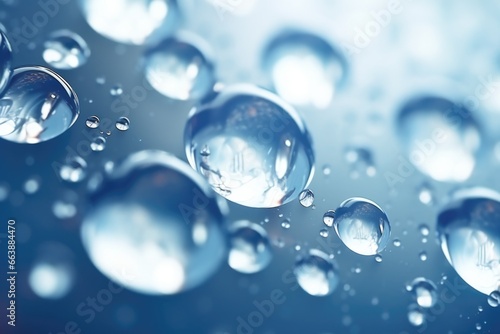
[28,242,74,299]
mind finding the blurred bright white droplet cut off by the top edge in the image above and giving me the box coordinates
[79,0,178,45]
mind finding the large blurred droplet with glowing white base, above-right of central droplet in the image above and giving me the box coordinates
[263,32,346,108]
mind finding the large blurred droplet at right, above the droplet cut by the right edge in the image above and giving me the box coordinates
[397,97,481,182]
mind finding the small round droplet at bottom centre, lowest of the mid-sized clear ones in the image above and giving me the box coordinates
[293,249,339,296]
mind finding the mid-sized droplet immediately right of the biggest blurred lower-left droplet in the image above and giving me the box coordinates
[228,220,272,274]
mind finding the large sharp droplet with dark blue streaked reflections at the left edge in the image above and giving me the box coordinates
[0,66,80,144]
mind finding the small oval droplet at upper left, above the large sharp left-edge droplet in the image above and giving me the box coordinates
[43,29,90,70]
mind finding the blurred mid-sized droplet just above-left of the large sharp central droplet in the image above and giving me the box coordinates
[144,36,215,101]
